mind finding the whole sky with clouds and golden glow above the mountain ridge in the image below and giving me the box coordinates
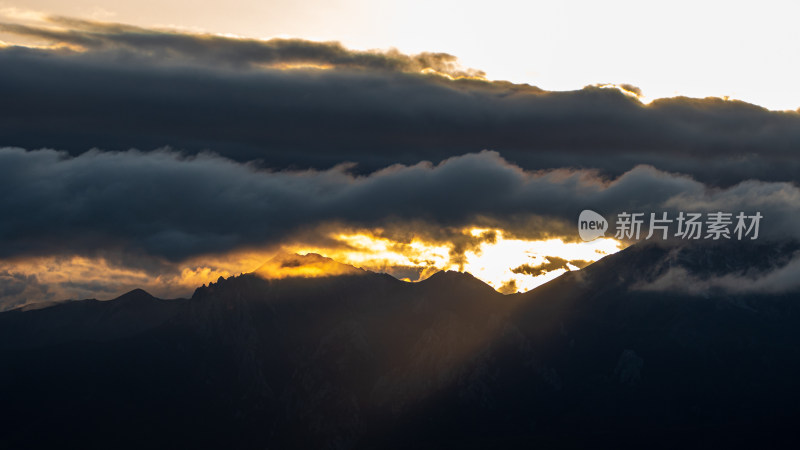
[0,1,800,309]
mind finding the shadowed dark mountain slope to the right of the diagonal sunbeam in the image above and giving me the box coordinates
[374,243,800,448]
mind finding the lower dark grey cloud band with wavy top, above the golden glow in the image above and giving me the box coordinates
[0,149,800,261]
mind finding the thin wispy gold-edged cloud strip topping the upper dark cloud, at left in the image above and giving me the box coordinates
[0,16,484,77]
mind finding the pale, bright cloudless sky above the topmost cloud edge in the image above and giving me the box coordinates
[6,0,800,110]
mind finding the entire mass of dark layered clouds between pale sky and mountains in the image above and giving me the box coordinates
[0,18,800,304]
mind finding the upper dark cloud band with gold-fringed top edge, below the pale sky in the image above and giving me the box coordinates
[0,19,800,186]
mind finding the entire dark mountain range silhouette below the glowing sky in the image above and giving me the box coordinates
[0,242,800,449]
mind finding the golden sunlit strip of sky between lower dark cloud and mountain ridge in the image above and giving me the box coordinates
[0,227,623,304]
